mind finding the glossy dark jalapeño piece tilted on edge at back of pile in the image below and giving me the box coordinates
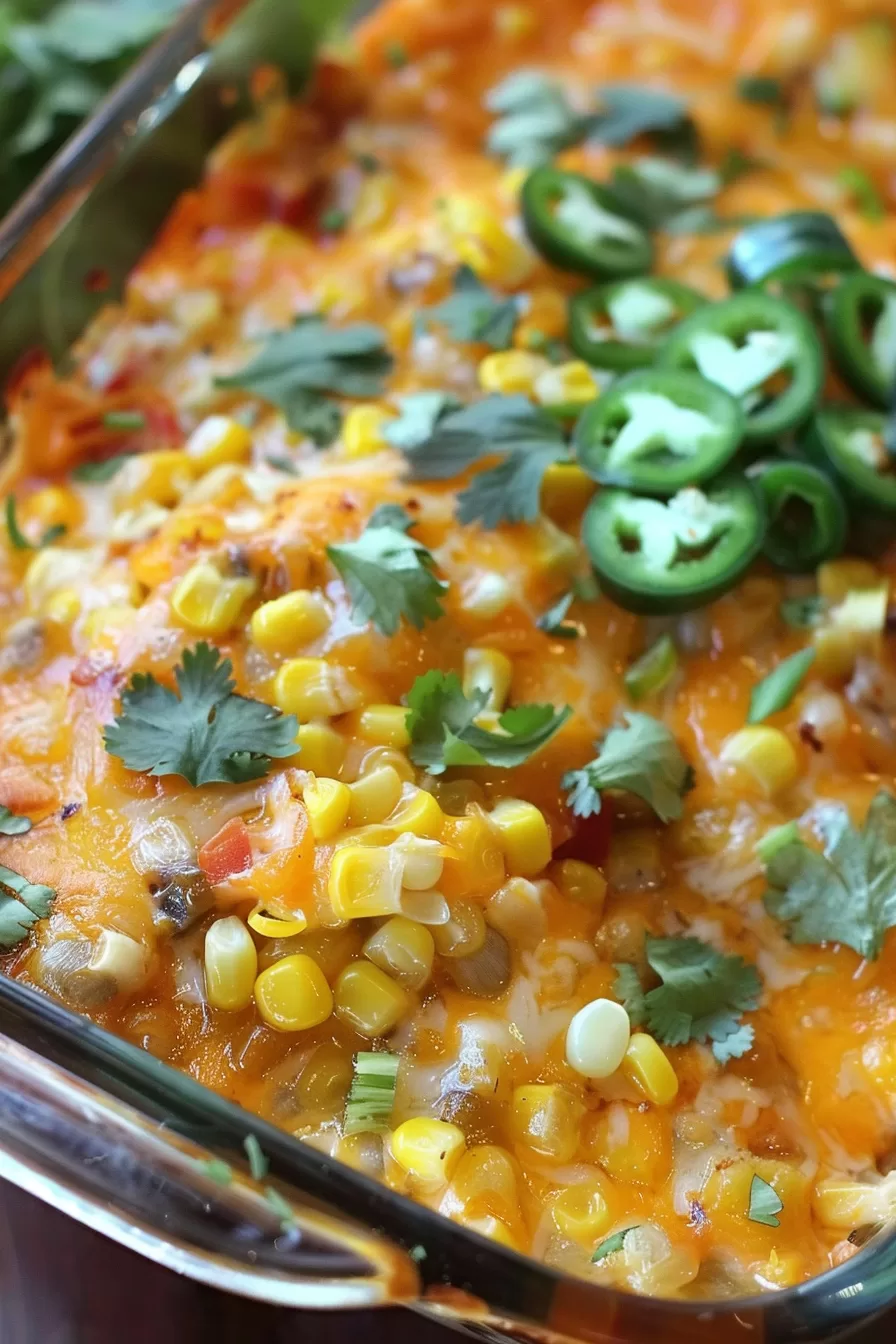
[725,210,858,289]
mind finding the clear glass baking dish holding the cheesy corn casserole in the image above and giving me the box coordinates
[0,0,896,1344]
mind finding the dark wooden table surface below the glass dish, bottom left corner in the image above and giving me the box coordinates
[0,1181,451,1344]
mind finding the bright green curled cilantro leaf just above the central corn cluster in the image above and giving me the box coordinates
[407,669,572,774]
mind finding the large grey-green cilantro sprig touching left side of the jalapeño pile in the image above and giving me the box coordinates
[404,395,568,528]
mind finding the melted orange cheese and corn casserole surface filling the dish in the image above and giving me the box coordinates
[0,0,896,1297]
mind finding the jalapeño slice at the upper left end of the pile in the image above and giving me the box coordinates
[520,168,653,280]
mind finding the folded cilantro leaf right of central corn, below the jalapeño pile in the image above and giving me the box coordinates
[563,711,693,821]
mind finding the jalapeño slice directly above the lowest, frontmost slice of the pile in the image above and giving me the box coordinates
[572,368,744,497]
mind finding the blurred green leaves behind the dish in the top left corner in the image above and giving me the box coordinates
[0,0,184,214]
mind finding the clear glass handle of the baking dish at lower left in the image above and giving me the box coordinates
[0,1035,419,1308]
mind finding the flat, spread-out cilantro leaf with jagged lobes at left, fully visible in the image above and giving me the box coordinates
[105,642,298,788]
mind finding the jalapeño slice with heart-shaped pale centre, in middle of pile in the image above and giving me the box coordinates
[657,290,825,444]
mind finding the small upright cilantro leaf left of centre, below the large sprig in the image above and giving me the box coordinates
[326,504,447,634]
